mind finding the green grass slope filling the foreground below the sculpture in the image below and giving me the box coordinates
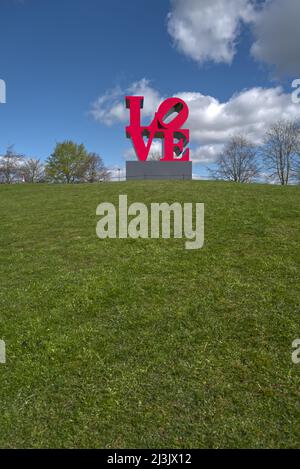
[0,181,300,448]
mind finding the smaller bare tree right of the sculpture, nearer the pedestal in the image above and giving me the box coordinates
[212,135,259,182]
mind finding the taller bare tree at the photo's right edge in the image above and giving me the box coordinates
[262,120,299,186]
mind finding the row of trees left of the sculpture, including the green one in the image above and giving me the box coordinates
[0,141,110,184]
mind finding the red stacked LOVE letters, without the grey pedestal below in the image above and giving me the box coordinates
[126,96,190,161]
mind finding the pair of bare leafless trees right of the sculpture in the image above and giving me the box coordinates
[210,120,300,185]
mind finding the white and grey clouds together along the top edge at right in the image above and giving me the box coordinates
[167,0,300,74]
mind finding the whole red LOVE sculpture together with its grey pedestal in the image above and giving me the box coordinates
[126,96,192,179]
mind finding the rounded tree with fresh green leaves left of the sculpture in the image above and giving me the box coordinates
[46,141,89,184]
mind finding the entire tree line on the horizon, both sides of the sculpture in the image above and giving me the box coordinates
[0,120,300,185]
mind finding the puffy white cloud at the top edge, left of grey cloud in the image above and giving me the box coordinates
[168,0,255,64]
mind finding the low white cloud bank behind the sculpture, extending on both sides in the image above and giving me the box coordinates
[93,79,300,163]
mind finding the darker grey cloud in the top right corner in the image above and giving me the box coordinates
[251,0,300,74]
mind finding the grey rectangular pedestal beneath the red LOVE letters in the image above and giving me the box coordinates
[126,161,192,181]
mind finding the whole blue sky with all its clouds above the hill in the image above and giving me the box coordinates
[0,0,300,177]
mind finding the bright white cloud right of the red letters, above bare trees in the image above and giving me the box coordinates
[177,87,300,163]
